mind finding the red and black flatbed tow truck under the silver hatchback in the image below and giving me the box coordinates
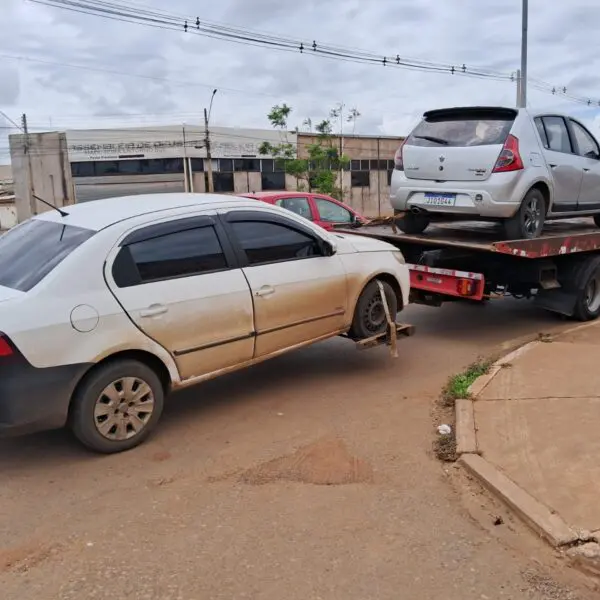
[343,217,600,321]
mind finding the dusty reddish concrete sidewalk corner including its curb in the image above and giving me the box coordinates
[457,323,600,546]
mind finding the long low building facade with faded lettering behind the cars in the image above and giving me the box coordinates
[12,125,402,216]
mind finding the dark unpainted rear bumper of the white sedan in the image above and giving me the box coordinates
[0,356,90,436]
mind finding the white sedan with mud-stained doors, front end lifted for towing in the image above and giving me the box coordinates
[0,194,409,453]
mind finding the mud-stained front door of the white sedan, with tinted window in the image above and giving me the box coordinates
[225,211,349,357]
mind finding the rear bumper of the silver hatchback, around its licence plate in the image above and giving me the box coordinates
[390,171,527,219]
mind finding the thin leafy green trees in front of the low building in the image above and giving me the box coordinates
[259,104,350,199]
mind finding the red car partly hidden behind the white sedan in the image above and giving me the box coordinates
[241,192,366,229]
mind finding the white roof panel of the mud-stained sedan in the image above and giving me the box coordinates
[34,193,264,231]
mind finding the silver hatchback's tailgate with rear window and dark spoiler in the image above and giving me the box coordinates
[402,108,518,181]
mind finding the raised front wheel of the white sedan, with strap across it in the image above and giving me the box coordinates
[350,281,398,340]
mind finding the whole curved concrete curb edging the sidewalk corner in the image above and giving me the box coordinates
[454,321,600,546]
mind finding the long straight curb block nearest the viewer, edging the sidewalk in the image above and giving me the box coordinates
[460,454,580,546]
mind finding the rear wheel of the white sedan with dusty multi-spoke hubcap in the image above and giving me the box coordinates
[70,360,165,454]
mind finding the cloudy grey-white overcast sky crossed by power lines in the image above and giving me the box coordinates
[0,0,600,162]
